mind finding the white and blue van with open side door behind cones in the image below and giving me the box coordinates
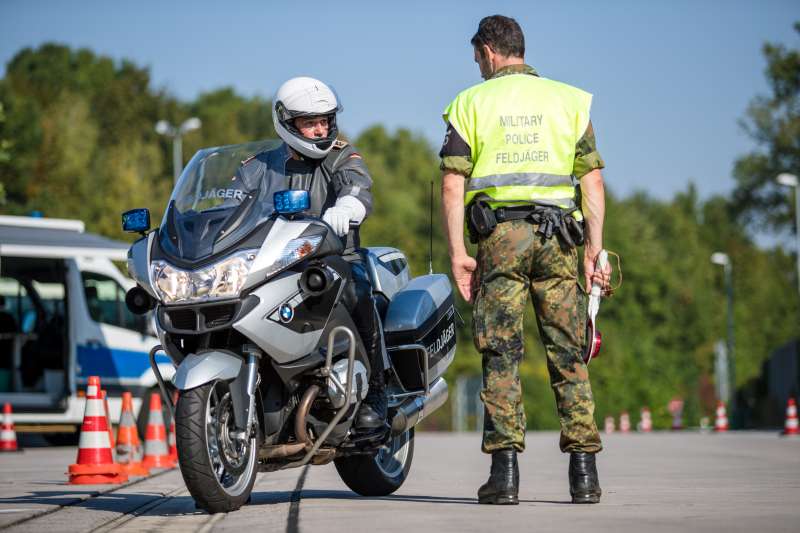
[0,216,174,442]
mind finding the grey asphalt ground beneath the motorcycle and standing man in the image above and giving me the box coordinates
[0,432,800,533]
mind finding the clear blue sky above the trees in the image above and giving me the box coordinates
[0,0,800,198]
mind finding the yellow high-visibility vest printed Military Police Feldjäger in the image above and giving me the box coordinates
[443,74,592,218]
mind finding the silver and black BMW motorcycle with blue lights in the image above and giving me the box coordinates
[123,141,456,513]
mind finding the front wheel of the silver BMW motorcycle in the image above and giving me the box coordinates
[175,381,258,513]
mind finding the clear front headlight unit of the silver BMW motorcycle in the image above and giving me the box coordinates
[150,250,258,304]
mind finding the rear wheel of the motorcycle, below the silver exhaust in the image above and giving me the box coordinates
[333,428,414,496]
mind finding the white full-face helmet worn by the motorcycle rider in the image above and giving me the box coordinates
[272,77,342,159]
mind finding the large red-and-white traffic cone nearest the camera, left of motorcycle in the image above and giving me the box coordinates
[69,376,128,485]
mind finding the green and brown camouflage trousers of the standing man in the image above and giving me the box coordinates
[472,220,602,453]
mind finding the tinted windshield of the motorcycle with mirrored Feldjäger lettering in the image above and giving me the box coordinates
[160,140,285,261]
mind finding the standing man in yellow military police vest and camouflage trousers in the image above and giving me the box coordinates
[439,15,610,504]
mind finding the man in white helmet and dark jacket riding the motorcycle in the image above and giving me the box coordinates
[242,77,387,429]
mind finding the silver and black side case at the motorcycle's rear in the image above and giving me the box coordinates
[384,274,456,391]
